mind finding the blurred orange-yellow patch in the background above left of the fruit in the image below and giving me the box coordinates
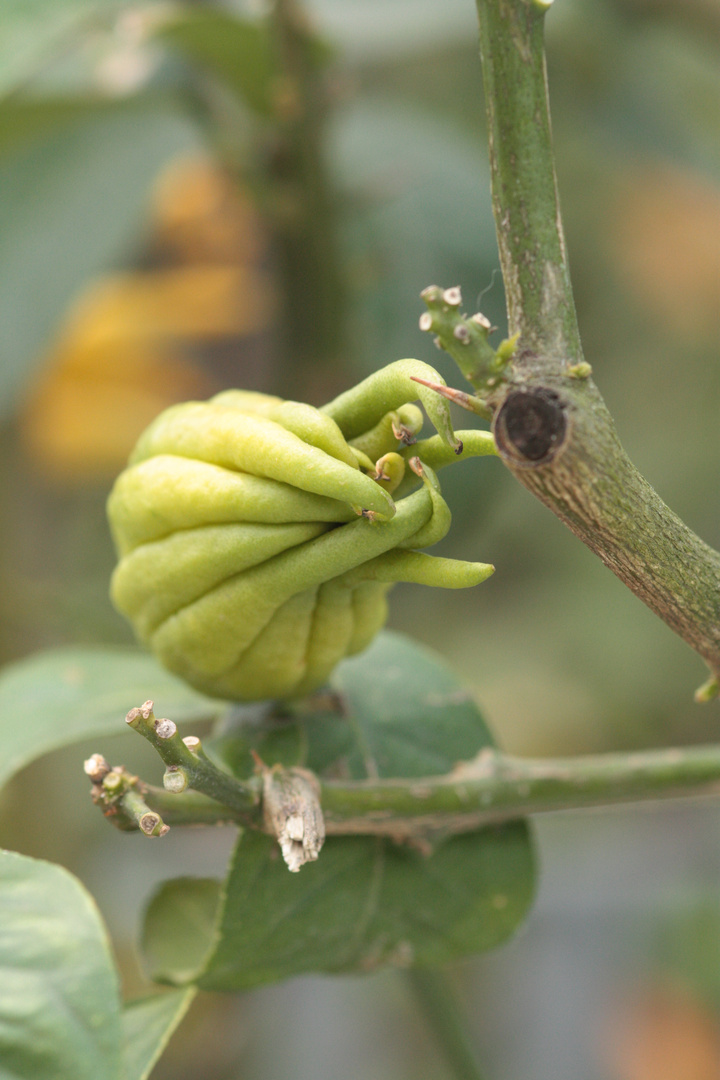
[19,158,272,483]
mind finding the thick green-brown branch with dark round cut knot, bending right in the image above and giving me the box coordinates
[477,0,720,675]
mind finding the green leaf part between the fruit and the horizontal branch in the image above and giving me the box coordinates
[212,632,492,780]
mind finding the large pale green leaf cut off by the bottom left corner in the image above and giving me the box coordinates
[0,851,121,1080]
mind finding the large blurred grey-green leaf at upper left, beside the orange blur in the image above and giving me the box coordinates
[0,106,196,414]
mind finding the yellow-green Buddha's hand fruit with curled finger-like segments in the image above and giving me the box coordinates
[108,360,493,701]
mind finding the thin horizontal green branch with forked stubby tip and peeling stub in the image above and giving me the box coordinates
[84,702,720,873]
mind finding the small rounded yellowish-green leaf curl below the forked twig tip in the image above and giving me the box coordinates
[142,878,220,984]
